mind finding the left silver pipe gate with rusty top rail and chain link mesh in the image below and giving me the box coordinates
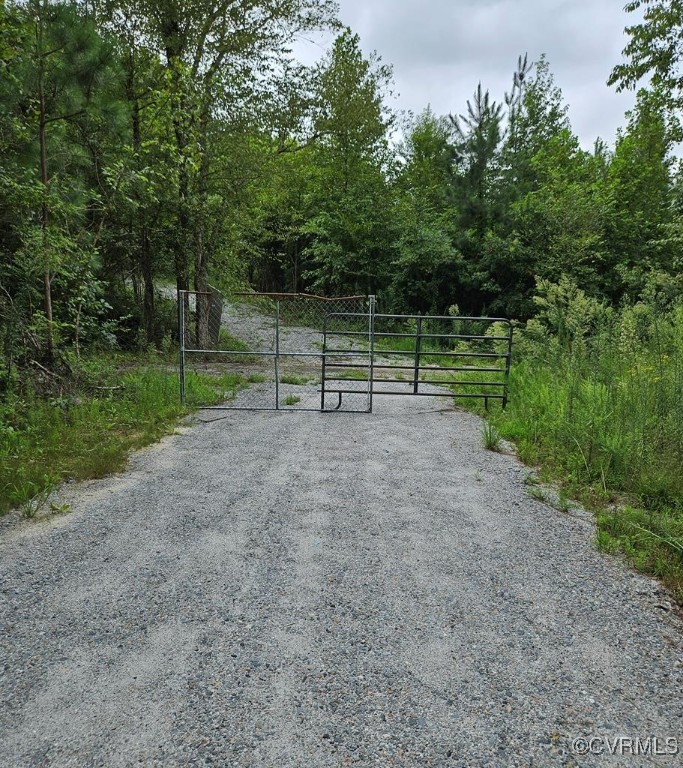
[178,289,370,412]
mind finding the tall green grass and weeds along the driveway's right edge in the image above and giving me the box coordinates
[480,283,683,600]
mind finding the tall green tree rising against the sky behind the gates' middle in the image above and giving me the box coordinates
[301,30,392,295]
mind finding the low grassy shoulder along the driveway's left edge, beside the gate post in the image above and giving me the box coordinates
[0,355,249,516]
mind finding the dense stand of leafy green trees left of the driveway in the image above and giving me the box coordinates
[0,0,344,368]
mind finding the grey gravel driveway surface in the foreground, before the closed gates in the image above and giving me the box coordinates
[0,397,683,768]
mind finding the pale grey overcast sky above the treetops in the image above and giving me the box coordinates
[300,0,637,149]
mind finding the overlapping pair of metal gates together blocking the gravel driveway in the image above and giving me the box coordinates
[178,290,512,413]
